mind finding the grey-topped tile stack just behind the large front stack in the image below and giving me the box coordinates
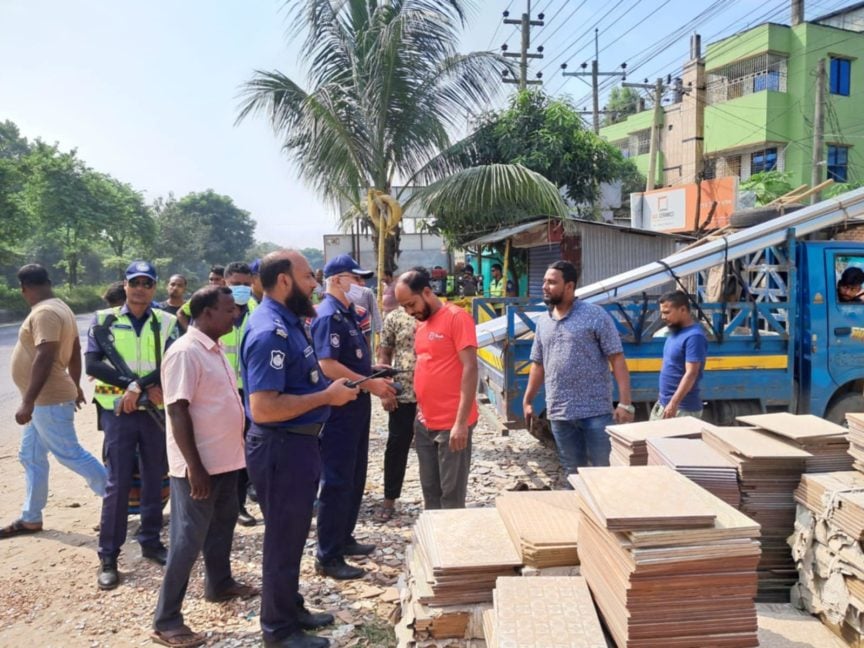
[648,437,741,508]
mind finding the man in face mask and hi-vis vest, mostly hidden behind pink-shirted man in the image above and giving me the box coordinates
[219,261,258,526]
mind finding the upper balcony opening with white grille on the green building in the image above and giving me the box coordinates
[706,53,787,105]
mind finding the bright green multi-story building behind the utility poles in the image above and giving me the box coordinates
[600,0,864,187]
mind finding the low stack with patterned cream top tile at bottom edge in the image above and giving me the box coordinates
[483,576,607,648]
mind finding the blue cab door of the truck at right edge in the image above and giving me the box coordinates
[812,244,864,413]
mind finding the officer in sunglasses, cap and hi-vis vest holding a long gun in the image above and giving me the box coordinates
[84,261,178,590]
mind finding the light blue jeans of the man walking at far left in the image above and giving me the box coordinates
[18,402,107,524]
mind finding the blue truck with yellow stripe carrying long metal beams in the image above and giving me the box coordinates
[473,190,864,437]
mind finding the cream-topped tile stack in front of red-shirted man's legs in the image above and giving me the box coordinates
[413,508,521,607]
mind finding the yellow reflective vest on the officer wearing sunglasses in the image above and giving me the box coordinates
[93,307,177,410]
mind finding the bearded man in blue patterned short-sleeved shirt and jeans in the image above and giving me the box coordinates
[522,261,635,475]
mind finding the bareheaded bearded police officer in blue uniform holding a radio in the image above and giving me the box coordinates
[240,250,358,648]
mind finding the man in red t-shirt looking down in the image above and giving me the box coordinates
[396,268,477,509]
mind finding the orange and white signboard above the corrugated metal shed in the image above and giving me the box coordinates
[630,176,738,232]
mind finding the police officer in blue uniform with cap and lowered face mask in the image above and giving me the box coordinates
[312,254,396,579]
